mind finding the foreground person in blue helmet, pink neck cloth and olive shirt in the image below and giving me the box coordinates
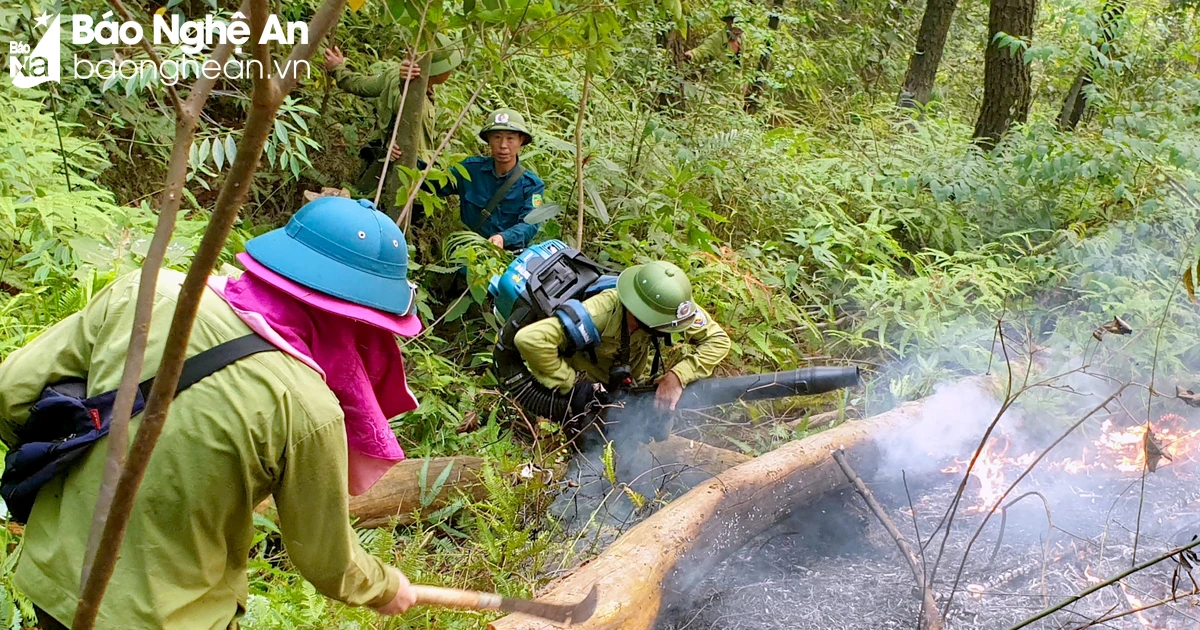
[0,197,421,630]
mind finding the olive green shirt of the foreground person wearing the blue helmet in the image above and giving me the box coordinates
[0,271,400,630]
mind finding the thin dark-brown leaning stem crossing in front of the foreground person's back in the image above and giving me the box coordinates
[71,0,346,630]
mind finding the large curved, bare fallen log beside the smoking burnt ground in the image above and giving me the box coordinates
[488,379,985,630]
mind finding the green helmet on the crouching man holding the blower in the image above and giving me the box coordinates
[617,260,696,332]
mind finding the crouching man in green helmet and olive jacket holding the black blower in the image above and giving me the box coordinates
[514,262,731,412]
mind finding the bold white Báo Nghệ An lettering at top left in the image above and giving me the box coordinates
[71,11,308,55]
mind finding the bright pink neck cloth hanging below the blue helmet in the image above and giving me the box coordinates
[218,271,416,494]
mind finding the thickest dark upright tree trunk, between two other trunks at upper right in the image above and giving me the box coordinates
[974,0,1038,150]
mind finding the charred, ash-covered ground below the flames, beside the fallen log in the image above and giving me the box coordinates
[656,466,1200,630]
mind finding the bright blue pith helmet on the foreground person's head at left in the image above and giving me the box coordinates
[246,197,415,316]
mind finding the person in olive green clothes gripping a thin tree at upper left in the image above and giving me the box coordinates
[325,34,463,210]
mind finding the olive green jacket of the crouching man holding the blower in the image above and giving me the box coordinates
[514,289,731,392]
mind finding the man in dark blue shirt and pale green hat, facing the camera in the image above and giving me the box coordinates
[436,109,546,250]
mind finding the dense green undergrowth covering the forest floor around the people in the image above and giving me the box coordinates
[0,0,1200,629]
